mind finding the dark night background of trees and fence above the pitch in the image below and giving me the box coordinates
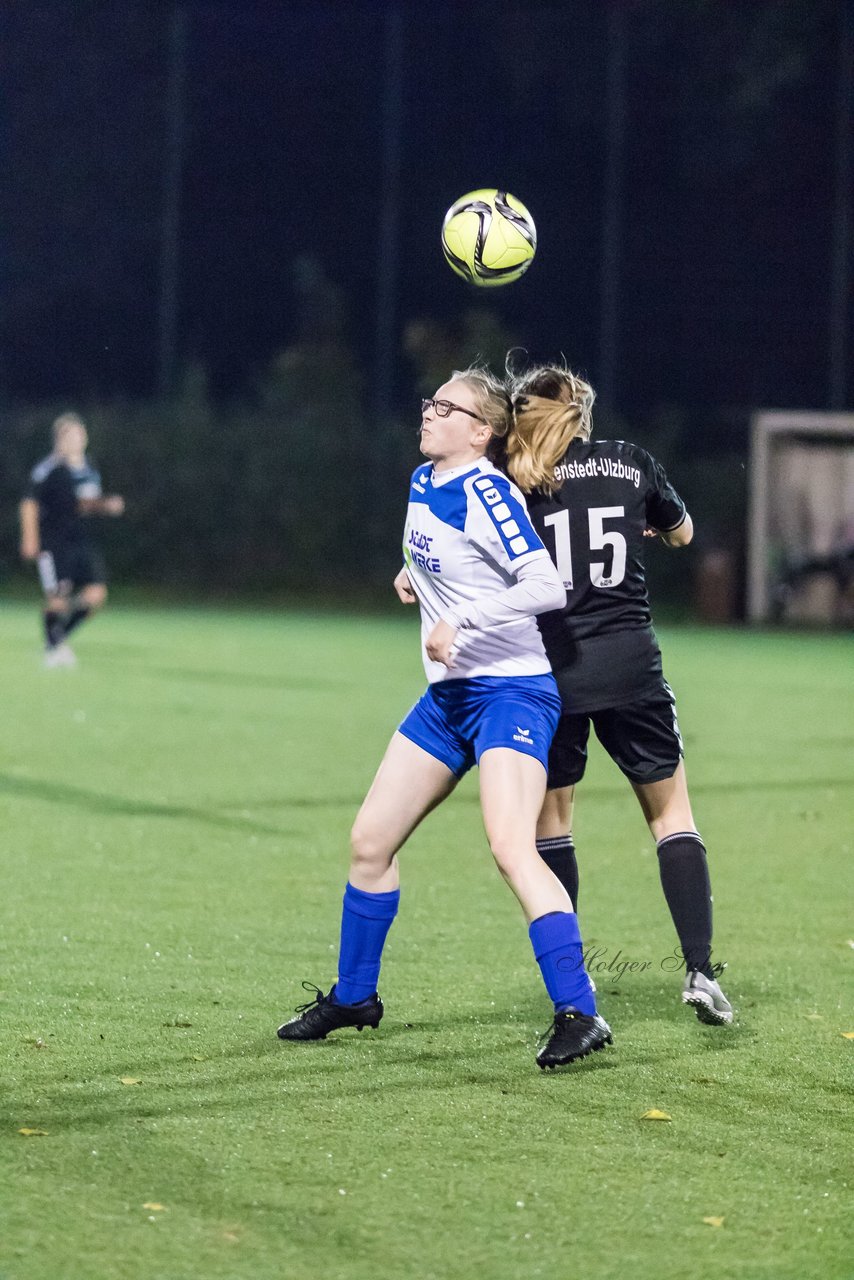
[0,0,853,601]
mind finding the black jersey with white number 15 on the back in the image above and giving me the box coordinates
[528,440,685,710]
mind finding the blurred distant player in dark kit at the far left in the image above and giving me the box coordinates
[20,413,124,667]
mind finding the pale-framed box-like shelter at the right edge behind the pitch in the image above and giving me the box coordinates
[748,410,854,623]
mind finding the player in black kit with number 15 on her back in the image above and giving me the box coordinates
[506,365,732,1025]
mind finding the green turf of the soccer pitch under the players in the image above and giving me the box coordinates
[0,605,854,1280]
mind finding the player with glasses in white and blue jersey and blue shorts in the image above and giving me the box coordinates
[279,369,611,1068]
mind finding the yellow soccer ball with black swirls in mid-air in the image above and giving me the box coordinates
[442,187,536,289]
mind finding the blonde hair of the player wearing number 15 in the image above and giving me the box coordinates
[504,365,595,493]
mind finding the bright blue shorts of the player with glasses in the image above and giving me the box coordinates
[399,675,561,778]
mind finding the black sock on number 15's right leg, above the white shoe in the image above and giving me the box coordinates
[658,831,714,978]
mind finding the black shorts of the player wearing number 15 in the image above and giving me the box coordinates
[548,680,682,791]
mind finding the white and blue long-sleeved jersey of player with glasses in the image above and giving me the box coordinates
[403,458,566,684]
